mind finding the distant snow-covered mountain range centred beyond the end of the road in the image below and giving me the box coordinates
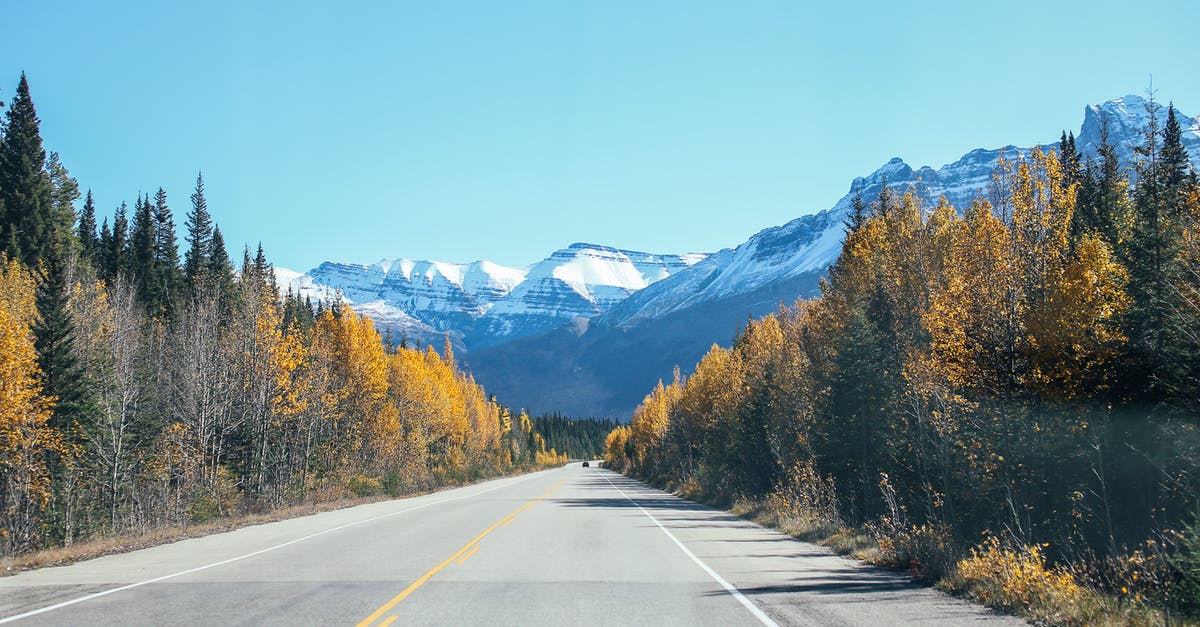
[276,244,706,350]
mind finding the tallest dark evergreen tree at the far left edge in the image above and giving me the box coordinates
[0,72,56,267]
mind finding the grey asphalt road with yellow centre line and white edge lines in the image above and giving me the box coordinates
[0,464,1024,626]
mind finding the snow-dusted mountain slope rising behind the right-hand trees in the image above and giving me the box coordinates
[466,96,1200,416]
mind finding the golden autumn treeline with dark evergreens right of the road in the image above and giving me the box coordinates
[606,105,1200,608]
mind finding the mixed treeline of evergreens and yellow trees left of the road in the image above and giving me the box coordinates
[0,74,565,556]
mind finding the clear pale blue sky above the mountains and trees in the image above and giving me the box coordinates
[0,0,1200,269]
